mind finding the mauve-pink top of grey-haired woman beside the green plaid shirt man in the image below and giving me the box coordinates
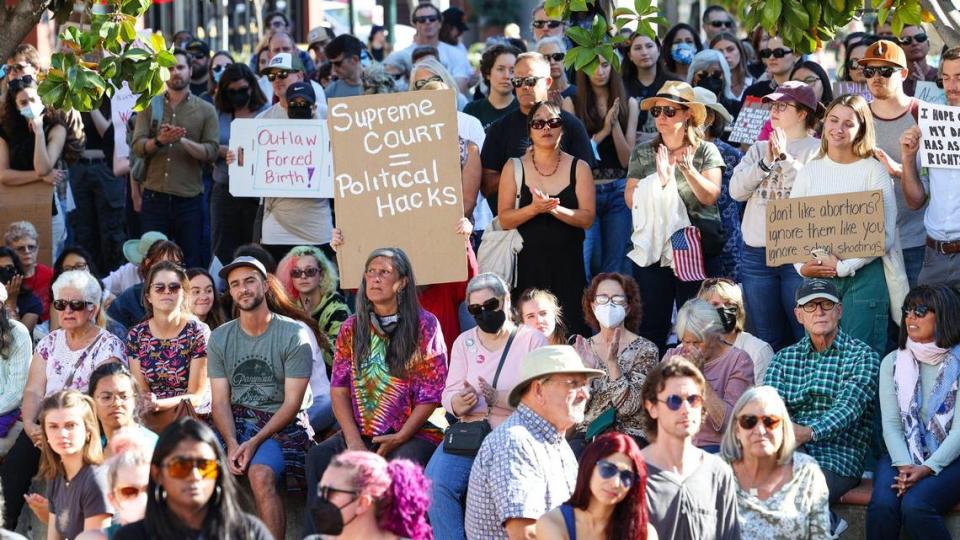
[663,347,754,447]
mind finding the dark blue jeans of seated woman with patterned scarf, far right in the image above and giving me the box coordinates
[867,456,960,540]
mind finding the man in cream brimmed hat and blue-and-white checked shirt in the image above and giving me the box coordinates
[464,345,603,538]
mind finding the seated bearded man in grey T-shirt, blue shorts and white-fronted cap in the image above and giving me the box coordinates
[207,257,313,538]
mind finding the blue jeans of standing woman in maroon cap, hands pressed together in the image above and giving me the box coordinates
[740,244,803,354]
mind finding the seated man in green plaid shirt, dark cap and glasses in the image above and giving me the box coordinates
[764,278,880,533]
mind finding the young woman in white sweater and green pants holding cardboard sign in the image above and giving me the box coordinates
[790,95,906,355]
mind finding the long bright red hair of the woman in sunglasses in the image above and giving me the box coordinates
[567,432,647,540]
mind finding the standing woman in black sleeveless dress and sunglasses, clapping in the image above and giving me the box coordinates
[498,102,595,334]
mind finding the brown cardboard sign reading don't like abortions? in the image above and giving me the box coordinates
[767,190,885,266]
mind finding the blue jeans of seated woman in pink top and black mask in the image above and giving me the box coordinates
[425,443,474,540]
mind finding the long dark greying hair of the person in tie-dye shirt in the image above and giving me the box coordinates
[353,248,420,377]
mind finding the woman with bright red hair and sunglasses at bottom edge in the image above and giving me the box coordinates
[537,432,657,540]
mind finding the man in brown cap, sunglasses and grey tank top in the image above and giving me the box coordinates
[860,40,927,288]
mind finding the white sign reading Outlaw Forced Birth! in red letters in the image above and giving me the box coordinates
[230,118,333,199]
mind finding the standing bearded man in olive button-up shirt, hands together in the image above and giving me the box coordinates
[132,49,220,268]
